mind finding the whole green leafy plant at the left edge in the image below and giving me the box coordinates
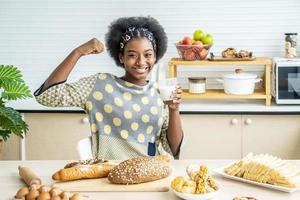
[0,65,32,152]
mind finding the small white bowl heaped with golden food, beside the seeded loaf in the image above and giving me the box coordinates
[171,164,220,200]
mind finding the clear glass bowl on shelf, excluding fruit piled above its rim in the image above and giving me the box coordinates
[175,44,212,61]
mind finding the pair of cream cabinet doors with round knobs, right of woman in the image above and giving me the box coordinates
[180,114,300,159]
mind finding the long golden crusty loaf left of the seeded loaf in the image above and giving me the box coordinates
[52,159,117,181]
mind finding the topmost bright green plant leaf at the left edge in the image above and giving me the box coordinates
[0,65,24,86]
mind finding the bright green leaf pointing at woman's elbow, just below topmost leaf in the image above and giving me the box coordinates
[1,82,32,100]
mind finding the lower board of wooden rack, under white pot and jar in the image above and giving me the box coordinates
[182,89,267,99]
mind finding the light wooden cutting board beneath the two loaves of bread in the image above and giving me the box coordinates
[53,176,171,192]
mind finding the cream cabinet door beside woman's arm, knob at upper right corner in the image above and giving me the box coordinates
[180,114,242,159]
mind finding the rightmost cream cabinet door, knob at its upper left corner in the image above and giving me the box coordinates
[242,115,300,159]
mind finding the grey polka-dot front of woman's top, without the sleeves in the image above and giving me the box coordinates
[85,73,164,159]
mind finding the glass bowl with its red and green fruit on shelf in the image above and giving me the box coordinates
[175,30,213,60]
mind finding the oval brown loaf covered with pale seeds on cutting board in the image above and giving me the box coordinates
[108,156,172,185]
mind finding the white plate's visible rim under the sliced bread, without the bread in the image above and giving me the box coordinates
[213,167,300,193]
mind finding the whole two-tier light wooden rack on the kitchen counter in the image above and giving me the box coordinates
[169,57,272,106]
